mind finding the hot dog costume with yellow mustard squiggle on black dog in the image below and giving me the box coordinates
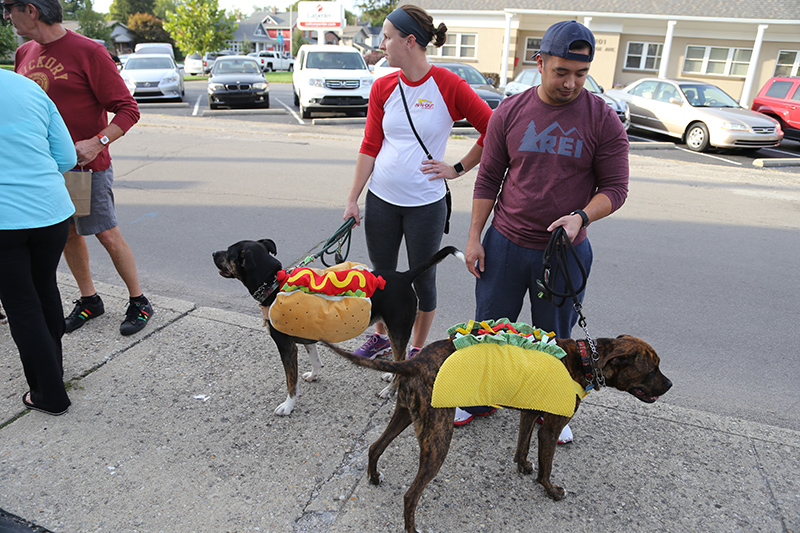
[266,261,386,342]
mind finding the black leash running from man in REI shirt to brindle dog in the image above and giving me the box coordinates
[536,226,606,393]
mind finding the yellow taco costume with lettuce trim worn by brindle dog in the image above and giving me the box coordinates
[431,318,586,416]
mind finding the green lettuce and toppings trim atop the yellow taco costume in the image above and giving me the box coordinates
[447,318,567,359]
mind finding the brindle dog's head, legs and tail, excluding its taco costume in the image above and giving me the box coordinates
[326,335,672,532]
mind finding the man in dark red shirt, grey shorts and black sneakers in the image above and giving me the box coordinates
[3,0,153,335]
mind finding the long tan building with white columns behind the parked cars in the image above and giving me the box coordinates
[400,0,800,106]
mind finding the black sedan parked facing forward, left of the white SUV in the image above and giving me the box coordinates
[208,56,269,109]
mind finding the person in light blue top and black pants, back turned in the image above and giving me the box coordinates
[0,69,77,415]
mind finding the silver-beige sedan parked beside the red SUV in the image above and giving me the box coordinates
[607,78,783,152]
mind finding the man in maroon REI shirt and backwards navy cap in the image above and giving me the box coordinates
[455,20,629,442]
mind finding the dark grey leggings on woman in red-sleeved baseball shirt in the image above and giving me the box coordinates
[364,191,447,312]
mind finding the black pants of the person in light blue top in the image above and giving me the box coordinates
[0,219,70,412]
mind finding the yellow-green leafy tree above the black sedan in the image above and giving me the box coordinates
[164,0,236,54]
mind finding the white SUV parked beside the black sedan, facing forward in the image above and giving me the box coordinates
[292,44,374,118]
